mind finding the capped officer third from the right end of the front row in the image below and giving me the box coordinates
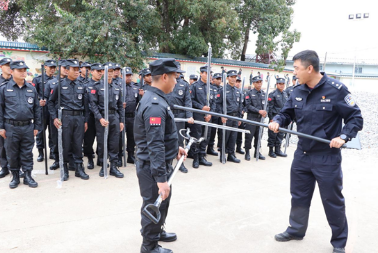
[217,70,243,163]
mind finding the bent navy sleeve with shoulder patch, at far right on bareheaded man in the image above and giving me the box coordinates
[336,87,363,139]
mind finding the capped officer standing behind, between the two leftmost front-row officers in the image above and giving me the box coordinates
[32,60,56,162]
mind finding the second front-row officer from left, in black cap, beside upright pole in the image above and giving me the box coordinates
[48,59,89,181]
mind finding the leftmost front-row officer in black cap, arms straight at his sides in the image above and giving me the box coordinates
[0,61,42,189]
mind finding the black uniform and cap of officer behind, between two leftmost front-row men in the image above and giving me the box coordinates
[32,60,56,162]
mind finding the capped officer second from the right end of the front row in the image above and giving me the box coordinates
[244,76,267,161]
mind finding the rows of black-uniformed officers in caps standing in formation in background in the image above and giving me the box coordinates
[0,58,296,188]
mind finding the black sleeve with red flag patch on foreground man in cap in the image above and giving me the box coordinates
[143,104,168,183]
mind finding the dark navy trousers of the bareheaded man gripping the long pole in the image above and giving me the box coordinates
[286,149,348,248]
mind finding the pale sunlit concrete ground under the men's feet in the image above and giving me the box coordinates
[0,143,378,253]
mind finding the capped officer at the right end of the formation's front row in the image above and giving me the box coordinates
[268,78,289,158]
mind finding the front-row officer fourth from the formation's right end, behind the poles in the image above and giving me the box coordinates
[191,66,216,169]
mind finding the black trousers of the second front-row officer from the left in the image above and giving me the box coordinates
[61,110,85,164]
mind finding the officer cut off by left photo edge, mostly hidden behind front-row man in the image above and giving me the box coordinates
[0,58,12,178]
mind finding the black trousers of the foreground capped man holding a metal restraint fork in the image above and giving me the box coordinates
[136,159,173,242]
